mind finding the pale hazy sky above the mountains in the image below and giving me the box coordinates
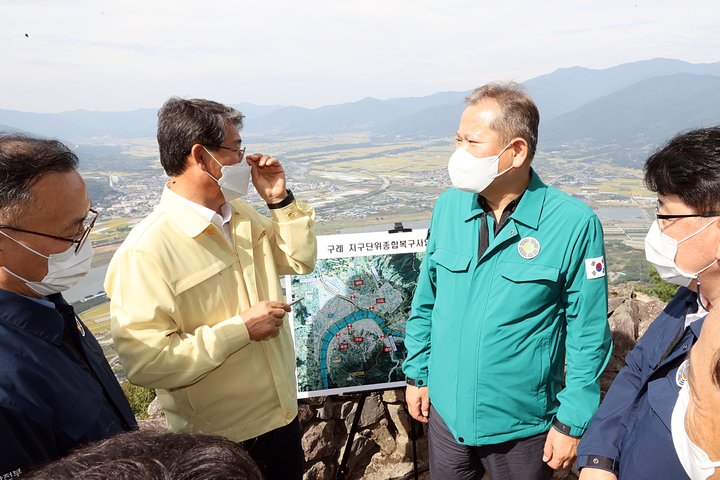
[0,0,720,112]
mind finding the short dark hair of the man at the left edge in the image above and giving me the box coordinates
[0,133,78,223]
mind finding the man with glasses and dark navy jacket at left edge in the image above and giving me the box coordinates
[0,134,137,478]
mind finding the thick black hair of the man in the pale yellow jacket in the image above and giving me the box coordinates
[157,97,243,177]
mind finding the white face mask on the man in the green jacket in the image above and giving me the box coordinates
[448,143,513,193]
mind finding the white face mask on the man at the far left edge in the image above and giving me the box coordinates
[0,230,93,295]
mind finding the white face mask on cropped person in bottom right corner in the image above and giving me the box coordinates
[670,383,720,480]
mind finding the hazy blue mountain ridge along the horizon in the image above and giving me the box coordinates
[0,58,720,167]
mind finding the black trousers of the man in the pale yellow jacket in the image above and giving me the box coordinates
[241,417,305,480]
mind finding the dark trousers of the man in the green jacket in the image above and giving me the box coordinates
[428,404,553,480]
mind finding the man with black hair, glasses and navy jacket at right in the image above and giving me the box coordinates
[578,127,720,480]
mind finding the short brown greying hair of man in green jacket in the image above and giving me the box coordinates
[465,82,540,161]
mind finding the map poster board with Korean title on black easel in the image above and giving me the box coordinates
[285,229,427,398]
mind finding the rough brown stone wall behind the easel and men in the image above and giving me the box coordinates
[144,285,665,480]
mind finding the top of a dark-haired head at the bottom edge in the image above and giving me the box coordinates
[24,430,262,480]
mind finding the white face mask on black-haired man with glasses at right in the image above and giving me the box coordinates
[645,220,717,287]
